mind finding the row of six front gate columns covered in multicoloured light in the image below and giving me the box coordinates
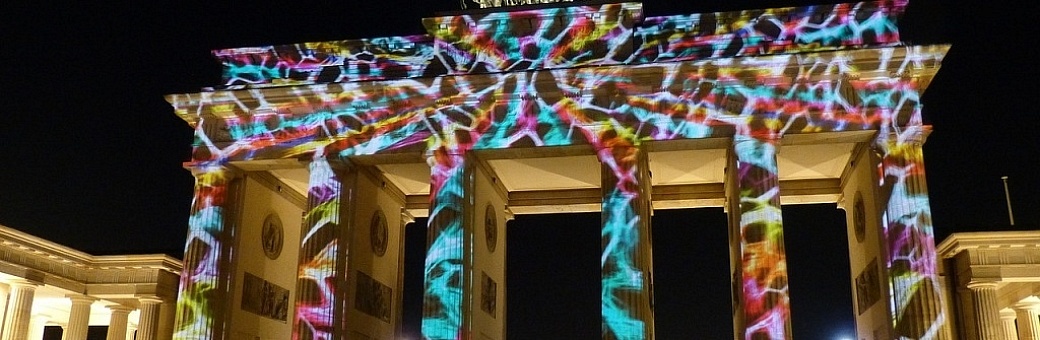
[177,131,943,339]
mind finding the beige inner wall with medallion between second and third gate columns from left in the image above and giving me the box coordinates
[344,162,405,339]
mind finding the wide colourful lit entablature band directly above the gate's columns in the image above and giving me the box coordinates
[170,46,946,161]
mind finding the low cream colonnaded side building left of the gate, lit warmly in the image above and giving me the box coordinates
[0,226,181,340]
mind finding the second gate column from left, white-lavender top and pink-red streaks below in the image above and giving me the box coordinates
[292,155,357,339]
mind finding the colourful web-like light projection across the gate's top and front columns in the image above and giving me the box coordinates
[167,1,948,339]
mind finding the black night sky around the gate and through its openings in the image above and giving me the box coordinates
[0,0,1040,339]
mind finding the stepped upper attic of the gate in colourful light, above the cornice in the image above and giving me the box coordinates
[213,0,907,87]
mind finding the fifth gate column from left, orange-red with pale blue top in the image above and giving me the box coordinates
[726,134,791,339]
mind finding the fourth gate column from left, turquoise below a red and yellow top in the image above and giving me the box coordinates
[597,146,654,340]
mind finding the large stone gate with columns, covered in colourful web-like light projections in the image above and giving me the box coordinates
[167,1,950,339]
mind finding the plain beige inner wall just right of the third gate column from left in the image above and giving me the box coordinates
[472,155,512,340]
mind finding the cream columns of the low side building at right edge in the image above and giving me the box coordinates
[967,281,1040,340]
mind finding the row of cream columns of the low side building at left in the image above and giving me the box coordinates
[0,281,162,340]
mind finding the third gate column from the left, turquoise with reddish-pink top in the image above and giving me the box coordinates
[422,148,469,340]
